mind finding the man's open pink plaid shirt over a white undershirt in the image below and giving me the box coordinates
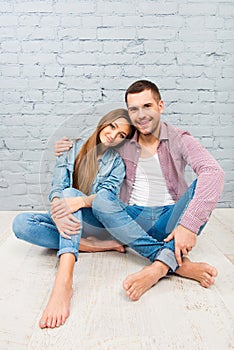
[118,122,224,233]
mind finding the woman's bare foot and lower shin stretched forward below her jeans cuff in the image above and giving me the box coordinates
[39,253,75,329]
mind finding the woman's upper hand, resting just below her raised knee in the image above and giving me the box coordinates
[51,197,84,219]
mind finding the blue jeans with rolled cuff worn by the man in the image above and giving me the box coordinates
[93,180,204,272]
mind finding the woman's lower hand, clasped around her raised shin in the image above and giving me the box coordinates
[52,214,81,239]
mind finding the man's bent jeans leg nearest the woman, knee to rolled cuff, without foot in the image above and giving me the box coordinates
[92,190,177,271]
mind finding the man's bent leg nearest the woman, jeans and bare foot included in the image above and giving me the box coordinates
[93,190,177,300]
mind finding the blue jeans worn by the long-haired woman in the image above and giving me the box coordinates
[12,188,113,260]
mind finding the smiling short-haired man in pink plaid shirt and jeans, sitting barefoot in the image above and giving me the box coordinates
[56,80,224,300]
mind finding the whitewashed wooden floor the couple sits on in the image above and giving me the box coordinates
[0,209,234,350]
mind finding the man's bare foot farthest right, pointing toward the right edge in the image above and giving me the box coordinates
[176,258,218,288]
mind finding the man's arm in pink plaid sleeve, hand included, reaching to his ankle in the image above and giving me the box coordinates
[165,133,224,265]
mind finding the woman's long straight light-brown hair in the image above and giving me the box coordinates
[73,108,134,195]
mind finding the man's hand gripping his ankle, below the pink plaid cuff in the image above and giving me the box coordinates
[164,225,197,266]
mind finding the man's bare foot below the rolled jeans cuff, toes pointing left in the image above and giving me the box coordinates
[123,261,169,301]
